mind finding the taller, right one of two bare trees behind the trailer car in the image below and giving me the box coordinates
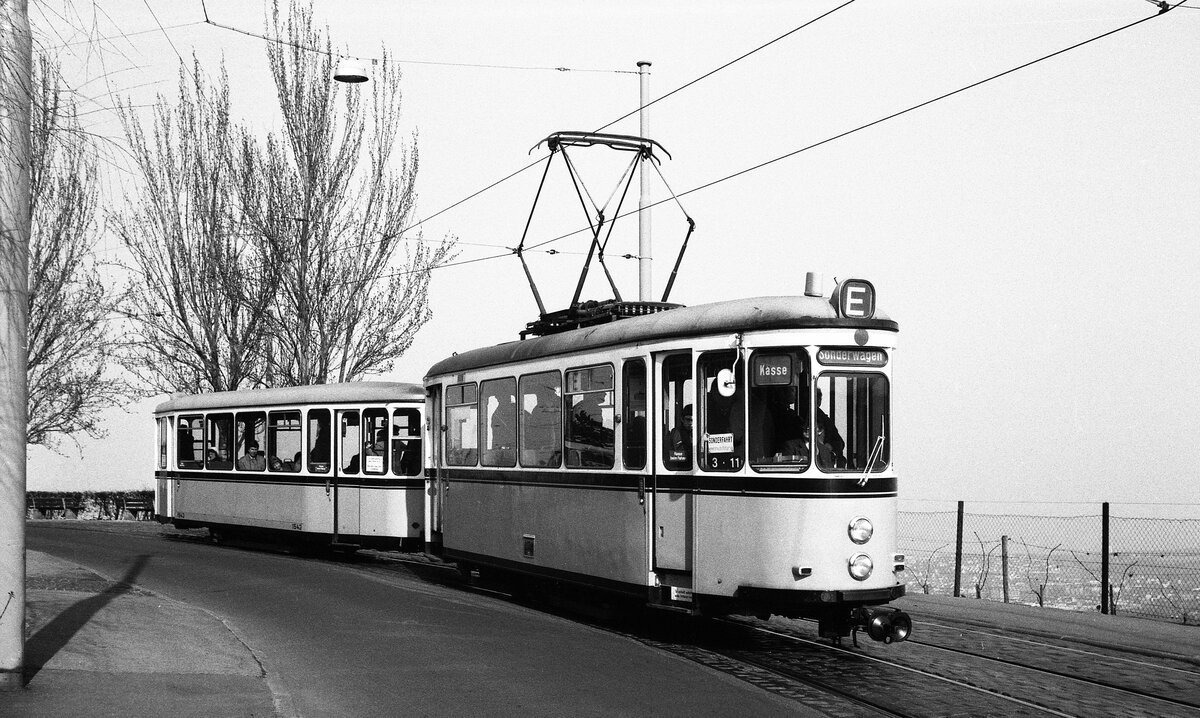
[239,2,454,384]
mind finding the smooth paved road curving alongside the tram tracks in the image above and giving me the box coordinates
[28,522,811,717]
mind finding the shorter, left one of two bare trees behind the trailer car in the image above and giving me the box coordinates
[114,58,278,393]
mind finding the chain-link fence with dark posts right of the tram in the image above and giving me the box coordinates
[899,502,1200,624]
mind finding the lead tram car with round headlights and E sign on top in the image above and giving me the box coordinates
[425,280,911,641]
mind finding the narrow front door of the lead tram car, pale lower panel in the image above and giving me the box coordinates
[653,352,696,572]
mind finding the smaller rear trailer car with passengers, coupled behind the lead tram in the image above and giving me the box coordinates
[155,382,426,549]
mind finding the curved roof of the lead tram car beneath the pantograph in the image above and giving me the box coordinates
[426,297,899,378]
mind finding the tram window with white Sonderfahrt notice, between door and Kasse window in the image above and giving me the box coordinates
[698,352,745,471]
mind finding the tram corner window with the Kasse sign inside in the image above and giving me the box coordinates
[749,348,812,472]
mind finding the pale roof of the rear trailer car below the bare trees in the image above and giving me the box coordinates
[154,382,425,414]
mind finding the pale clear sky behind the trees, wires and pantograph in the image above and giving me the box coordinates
[21,0,1200,516]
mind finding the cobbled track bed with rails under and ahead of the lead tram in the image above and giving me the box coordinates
[182,537,1200,718]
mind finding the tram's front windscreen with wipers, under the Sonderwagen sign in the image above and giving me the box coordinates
[814,372,892,472]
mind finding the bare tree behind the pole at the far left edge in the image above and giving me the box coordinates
[26,56,130,448]
